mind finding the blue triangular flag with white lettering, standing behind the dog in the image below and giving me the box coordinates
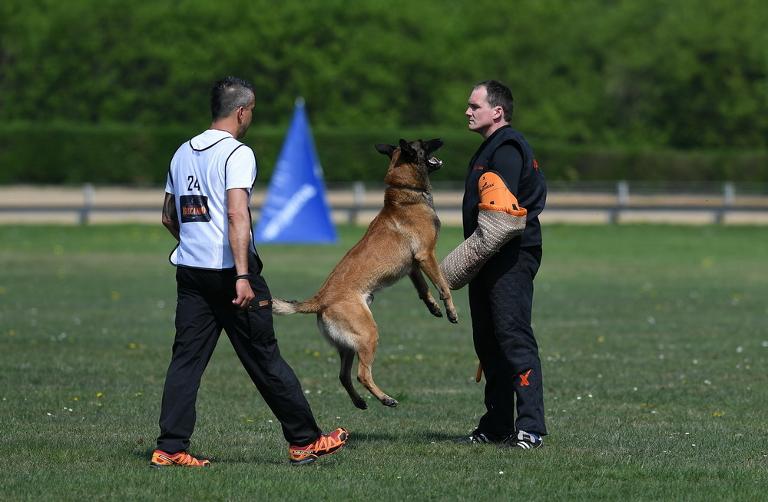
[255,98,336,243]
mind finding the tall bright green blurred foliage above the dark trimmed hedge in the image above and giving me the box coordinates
[0,0,768,149]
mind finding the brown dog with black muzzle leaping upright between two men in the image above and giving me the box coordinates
[272,139,458,409]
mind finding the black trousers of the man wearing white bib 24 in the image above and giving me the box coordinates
[157,255,320,453]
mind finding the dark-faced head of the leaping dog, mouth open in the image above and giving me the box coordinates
[376,139,443,190]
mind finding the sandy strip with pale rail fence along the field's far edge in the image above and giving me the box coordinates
[0,181,768,225]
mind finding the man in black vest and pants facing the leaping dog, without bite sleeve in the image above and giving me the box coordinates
[462,80,547,449]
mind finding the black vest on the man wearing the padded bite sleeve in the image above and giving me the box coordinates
[462,126,547,248]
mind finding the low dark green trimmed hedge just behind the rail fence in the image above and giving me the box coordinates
[0,124,768,185]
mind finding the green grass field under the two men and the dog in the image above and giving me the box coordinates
[0,225,768,500]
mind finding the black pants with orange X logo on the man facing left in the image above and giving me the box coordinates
[469,246,547,437]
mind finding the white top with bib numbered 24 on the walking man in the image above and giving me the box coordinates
[165,129,256,270]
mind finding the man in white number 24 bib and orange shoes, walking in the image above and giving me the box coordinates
[150,77,348,467]
